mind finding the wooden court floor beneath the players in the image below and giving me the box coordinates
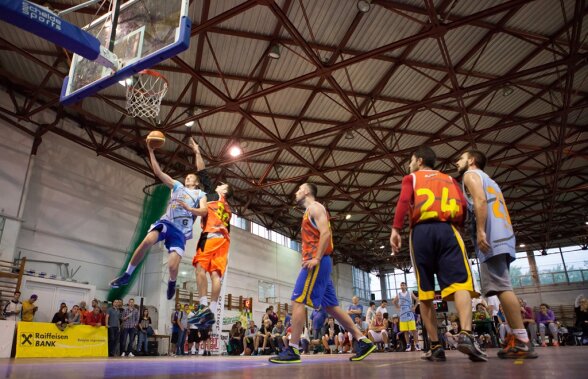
[0,347,588,379]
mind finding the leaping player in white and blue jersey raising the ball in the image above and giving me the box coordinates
[110,138,207,300]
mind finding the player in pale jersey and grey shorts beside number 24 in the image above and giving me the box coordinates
[455,150,537,359]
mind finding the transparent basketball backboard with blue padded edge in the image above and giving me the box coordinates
[61,0,191,105]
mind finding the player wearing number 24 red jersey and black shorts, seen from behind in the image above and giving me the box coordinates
[390,146,488,361]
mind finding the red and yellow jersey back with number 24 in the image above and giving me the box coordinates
[410,170,465,226]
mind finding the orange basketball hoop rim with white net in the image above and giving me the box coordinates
[127,70,168,118]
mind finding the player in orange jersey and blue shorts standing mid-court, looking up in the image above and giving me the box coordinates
[269,183,376,363]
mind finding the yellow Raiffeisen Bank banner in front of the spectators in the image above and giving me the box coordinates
[16,321,108,358]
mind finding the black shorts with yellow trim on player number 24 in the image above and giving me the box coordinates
[410,222,479,300]
